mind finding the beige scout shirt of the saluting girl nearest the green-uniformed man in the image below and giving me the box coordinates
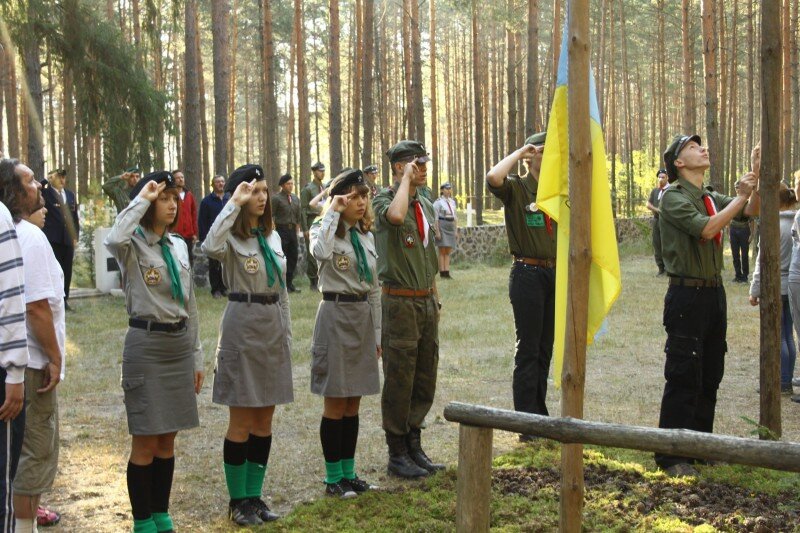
[309,209,381,344]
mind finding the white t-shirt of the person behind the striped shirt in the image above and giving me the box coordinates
[17,220,67,379]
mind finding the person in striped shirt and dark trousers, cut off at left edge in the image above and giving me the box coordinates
[0,159,33,531]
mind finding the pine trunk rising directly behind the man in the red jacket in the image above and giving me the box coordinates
[182,0,203,191]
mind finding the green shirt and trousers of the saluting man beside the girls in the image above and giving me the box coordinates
[372,185,439,438]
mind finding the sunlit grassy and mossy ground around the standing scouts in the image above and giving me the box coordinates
[45,246,800,531]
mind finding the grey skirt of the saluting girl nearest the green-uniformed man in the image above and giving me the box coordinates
[311,300,380,398]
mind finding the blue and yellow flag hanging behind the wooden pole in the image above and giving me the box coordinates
[536,8,622,387]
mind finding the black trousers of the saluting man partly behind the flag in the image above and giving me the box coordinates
[508,263,556,415]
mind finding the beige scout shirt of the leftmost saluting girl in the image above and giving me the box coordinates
[103,197,203,370]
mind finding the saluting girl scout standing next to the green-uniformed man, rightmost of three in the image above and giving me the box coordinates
[310,170,381,498]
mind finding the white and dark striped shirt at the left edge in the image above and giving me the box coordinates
[0,202,28,383]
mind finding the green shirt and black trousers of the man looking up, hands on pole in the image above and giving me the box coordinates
[655,178,734,469]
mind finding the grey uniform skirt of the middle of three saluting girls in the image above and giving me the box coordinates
[212,302,294,407]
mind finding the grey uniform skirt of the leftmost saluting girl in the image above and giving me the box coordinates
[122,328,200,435]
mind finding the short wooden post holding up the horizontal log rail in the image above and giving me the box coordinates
[456,424,492,533]
